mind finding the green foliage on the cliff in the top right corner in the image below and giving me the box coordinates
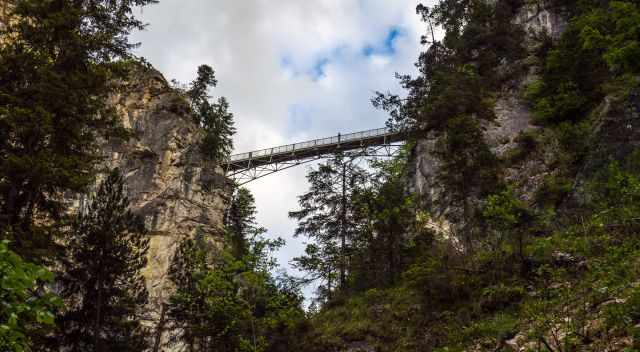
[527,1,640,124]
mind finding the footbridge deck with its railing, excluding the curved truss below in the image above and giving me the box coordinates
[227,128,406,172]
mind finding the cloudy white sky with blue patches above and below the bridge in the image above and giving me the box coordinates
[132,0,425,296]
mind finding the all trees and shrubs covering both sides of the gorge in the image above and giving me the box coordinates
[0,0,640,352]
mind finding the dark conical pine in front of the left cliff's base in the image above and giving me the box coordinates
[60,169,149,352]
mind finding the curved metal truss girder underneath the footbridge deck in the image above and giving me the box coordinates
[227,143,403,186]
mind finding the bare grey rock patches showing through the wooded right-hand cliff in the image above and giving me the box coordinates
[409,4,566,237]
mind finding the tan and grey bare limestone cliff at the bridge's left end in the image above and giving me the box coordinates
[103,68,229,326]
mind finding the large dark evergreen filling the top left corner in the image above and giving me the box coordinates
[0,0,155,260]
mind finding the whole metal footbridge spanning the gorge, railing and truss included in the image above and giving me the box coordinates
[225,128,407,185]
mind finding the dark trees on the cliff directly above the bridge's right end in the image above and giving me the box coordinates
[373,0,525,131]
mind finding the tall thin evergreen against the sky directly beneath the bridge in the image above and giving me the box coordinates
[289,155,365,295]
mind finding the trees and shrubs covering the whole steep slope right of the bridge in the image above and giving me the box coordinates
[296,0,640,351]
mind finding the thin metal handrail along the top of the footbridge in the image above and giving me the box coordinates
[229,127,393,162]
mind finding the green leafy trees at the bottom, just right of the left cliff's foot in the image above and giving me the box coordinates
[168,189,304,352]
